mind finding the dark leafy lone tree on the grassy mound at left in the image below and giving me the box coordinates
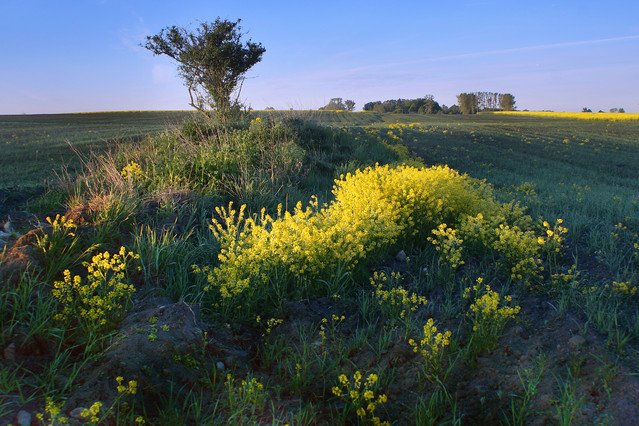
[143,18,266,121]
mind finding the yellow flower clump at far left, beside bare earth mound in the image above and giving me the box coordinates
[51,247,139,331]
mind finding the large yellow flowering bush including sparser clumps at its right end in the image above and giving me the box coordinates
[194,166,556,318]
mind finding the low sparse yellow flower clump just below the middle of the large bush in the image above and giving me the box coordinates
[370,272,428,320]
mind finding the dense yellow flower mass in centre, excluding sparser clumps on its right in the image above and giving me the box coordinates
[194,166,520,312]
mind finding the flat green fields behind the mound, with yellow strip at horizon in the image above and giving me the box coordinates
[6,111,639,243]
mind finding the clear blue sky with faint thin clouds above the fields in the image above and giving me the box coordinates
[0,0,639,114]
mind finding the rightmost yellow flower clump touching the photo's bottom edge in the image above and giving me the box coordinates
[331,371,390,425]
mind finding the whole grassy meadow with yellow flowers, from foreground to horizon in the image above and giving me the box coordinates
[0,111,639,425]
